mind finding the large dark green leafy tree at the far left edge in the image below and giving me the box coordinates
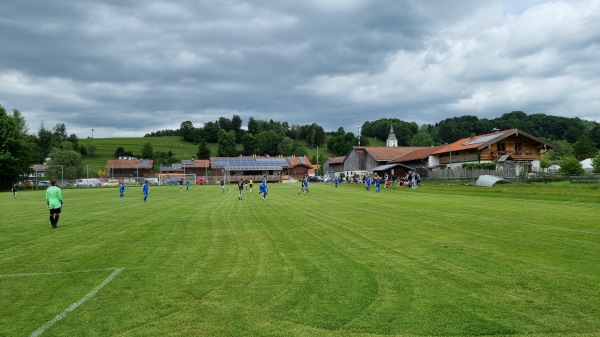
[0,105,36,187]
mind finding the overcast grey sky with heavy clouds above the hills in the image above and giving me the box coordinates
[0,0,600,138]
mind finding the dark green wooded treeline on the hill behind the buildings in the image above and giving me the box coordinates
[145,111,600,159]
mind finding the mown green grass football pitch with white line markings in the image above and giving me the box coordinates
[0,183,600,337]
